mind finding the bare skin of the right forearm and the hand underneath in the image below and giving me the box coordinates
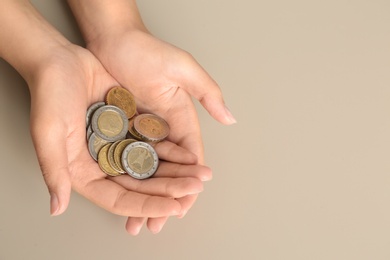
[68,0,236,234]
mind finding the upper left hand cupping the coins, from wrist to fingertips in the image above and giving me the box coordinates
[28,44,211,232]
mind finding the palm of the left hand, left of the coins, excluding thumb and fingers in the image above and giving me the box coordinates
[32,47,116,181]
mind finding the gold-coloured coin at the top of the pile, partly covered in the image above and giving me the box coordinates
[106,87,137,118]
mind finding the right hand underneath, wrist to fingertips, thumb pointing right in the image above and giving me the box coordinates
[88,30,235,232]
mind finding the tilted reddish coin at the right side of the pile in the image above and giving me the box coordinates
[133,114,169,142]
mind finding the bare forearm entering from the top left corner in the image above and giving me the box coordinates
[0,0,69,83]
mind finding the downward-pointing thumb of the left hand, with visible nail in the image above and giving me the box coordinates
[31,123,71,216]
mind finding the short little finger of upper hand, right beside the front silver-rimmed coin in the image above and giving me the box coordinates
[154,141,198,164]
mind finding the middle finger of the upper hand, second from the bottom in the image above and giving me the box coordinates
[110,175,203,198]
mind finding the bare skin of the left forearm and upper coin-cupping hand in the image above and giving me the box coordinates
[0,0,211,233]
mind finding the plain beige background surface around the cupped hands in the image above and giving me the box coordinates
[0,0,390,260]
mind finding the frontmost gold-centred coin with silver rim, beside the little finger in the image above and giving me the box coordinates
[122,142,158,179]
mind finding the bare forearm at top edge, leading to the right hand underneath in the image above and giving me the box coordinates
[67,0,147,45]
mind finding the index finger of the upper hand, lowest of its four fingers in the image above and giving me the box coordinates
[79,179,181,217]
